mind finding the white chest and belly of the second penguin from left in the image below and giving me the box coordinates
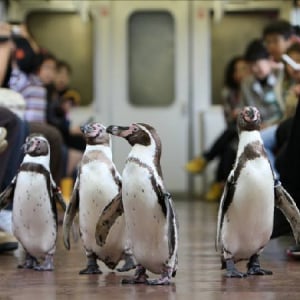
[79,151,124,254]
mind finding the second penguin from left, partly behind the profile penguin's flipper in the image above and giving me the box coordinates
[63,122,135,274]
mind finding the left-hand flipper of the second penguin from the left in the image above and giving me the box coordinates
[63,179,79,250]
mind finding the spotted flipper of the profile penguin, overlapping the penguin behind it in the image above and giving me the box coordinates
[95,191,124,246]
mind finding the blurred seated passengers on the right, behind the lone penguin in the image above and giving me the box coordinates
[186,20,300,200]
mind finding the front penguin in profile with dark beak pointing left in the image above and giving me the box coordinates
[96,123,178,285]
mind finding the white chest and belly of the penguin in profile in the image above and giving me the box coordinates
[122,157,169,273]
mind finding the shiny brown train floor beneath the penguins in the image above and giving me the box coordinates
[0,199,300,300]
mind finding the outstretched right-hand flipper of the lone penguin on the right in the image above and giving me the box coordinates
[275,182,300,244]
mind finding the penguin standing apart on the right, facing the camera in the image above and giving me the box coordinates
[216,106,300,278]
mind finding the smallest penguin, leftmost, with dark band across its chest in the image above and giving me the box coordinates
[0,134,65,271]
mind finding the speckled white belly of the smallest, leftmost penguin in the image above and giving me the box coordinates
[12,171,57,256]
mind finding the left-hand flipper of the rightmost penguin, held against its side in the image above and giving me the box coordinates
[215,171,235,251]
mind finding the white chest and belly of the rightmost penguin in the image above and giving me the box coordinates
[222,135,274,259]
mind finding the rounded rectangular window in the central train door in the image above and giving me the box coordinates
[128,11,175,107]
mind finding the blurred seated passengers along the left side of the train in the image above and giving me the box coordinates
[0,23,85,252]
